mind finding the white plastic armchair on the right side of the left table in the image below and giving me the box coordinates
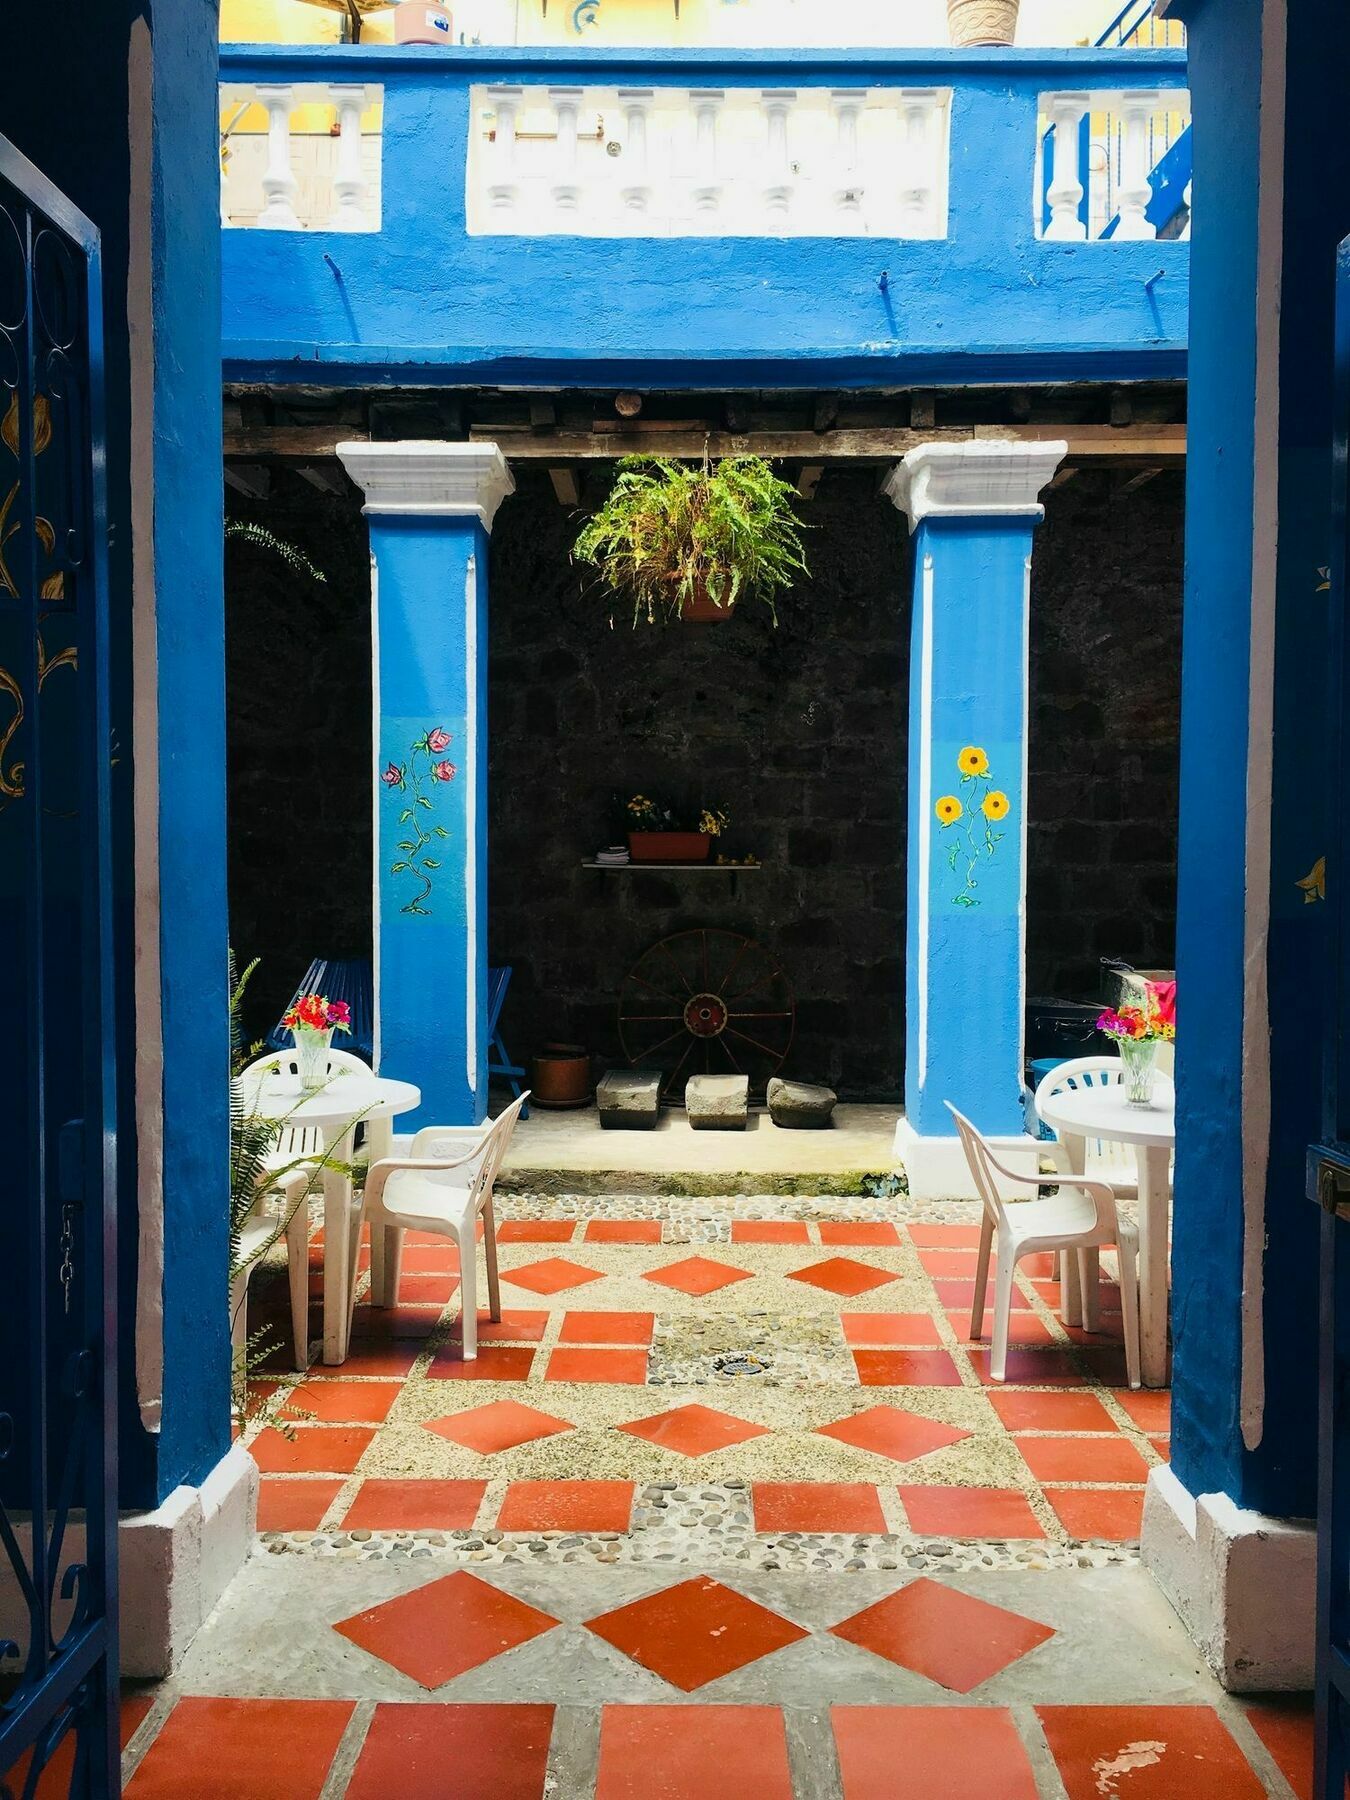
[353,1091,529,1363]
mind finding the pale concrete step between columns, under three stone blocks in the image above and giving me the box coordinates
[497,1105,900,1193]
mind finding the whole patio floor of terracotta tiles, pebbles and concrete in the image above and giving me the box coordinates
[68,1195,1310,1800]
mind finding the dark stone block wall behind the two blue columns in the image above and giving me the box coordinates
[227,457,1181,1098]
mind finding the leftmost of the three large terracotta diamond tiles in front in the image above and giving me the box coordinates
[333,1570,558,1688]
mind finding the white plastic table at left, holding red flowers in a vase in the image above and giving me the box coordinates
[245,1071,421,1363]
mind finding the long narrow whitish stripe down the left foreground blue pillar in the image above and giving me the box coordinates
[126,18,164,1431]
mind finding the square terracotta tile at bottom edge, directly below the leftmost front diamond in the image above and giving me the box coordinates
[354,1703,553,1800]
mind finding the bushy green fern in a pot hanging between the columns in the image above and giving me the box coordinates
[572,455,806,625]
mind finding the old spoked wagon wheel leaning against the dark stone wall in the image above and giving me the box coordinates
[619,929,797,1100]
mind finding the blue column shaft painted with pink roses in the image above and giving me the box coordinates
[371,513,488,1130]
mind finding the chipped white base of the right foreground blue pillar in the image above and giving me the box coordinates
[1141,1467,1318,1694]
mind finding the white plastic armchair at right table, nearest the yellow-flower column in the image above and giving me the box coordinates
[947,1100,1139,1388]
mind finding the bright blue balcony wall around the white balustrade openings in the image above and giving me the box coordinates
[221,45,1190,387]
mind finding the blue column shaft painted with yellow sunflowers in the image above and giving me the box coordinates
[905,517,1033,1138]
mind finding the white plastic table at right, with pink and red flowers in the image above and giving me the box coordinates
[1040,1080,1177,1388]
